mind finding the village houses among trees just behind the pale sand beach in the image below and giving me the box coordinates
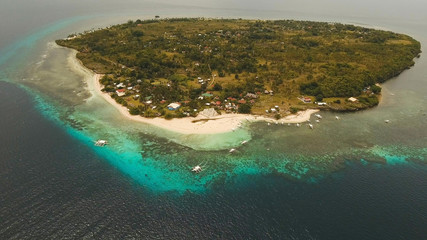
[101,72,372,119]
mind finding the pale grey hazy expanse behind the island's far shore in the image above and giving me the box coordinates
[0,0,427,48]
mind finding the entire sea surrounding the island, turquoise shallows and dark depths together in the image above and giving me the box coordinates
[0,0,427,240]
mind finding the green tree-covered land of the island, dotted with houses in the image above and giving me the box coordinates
[57,18,420,118]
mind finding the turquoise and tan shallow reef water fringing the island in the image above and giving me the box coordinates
[0,11,426,193]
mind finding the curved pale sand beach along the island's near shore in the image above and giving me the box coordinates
[70,51,319,134]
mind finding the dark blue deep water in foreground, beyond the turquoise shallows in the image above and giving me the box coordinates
[0,83,427,236]
